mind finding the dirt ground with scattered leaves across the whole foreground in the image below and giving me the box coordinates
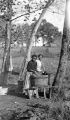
[0,95,70,120]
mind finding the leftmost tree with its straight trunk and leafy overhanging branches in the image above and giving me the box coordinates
[0,0,54,85]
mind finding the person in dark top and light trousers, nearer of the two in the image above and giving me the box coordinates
[24,55,37,89]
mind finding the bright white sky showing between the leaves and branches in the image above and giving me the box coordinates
[14,0,64,31]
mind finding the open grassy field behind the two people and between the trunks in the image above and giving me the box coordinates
[0,47,70,84]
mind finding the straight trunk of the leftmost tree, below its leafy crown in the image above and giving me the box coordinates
[0,21,11,85]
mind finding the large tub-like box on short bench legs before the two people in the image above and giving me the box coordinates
[28,74,50,99]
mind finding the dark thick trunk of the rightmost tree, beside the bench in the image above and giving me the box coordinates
[53,0,70,89]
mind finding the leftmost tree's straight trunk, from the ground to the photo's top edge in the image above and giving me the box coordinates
[0,0,12,85]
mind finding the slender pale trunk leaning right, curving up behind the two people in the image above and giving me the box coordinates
[19,0,54,80]
